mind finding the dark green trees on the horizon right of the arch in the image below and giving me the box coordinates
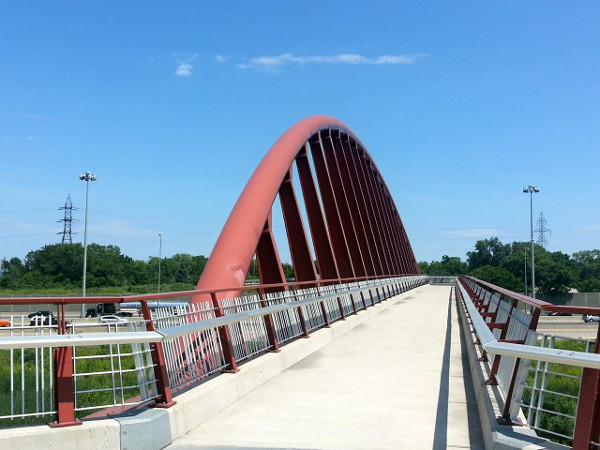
[419,237,600,295]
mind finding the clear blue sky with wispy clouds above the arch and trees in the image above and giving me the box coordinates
[0,0,600,261]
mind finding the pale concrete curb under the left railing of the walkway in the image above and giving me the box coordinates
[0,286,422,450]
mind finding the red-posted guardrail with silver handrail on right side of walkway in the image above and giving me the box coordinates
[456,277,600,449]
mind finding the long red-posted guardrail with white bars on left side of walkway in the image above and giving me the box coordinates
[0,276,427,426]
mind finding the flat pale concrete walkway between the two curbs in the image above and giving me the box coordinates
[168,285,483,450]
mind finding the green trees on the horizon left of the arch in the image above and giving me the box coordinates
[0,243,208,292]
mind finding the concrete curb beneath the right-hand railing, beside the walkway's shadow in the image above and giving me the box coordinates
[456,288,570,450]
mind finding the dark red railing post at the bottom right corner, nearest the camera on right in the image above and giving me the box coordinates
[573,325,600,449]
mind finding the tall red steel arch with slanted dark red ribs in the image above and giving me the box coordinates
[197,116,420,298]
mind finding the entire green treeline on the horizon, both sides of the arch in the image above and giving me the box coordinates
[0,237,600,294]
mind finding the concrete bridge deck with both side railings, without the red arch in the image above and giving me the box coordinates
[0,276,600,449]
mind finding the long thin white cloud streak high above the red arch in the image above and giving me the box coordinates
[238,53,426,70]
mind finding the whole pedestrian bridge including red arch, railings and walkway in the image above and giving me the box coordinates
[0,116,600,449]
